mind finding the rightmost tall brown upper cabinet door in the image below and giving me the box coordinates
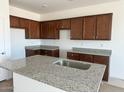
[96,14,112,40]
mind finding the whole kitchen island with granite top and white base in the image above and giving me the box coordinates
[0,55,105,92]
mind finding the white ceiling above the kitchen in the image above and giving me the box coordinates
[9,0,117,14]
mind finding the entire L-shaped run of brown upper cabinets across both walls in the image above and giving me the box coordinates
[10,13,112,40]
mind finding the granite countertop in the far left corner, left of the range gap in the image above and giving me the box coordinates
[25,45,59,50]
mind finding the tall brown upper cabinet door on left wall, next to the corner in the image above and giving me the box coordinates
[29,20,40,39]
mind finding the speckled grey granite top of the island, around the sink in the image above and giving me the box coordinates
[0,55,105,92]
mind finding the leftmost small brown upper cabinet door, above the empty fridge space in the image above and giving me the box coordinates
[10,16,20,28]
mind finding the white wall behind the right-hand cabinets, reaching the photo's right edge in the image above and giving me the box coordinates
[41,0,124,79]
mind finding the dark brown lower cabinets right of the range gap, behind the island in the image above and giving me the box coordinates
[67,52,110,81]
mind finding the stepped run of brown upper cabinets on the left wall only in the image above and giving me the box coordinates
[10,16,40,39]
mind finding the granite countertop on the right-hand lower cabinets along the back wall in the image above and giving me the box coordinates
[68,47,112,56]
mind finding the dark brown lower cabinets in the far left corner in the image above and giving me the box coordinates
[25,49,59,57]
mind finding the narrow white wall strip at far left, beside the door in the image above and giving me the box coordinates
[0,0,10,57]
